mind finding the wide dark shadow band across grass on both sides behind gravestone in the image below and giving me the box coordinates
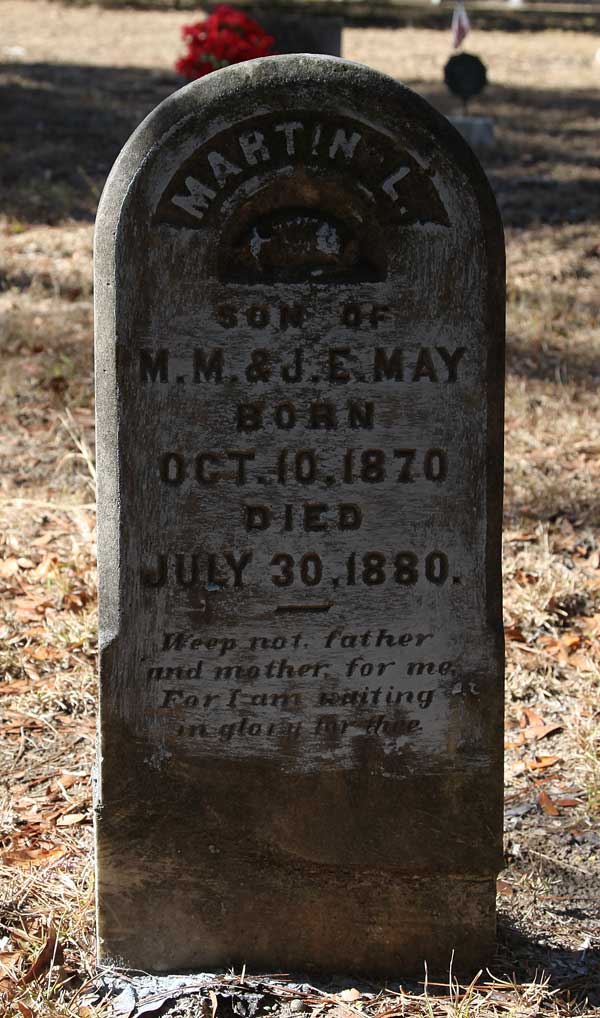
[0,63,600,226]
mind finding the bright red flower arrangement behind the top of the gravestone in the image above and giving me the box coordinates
[175,4,275,81]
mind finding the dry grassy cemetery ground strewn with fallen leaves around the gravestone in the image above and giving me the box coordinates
[0,0,600,1018]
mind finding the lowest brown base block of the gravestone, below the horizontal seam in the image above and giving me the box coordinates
[97,867,495,981]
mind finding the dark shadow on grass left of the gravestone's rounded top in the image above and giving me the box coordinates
[0,63,181,224]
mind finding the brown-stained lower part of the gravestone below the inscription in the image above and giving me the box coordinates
[98,741,501,979]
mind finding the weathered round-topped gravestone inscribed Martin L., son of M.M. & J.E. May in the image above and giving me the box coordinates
[96,56,504,976]
